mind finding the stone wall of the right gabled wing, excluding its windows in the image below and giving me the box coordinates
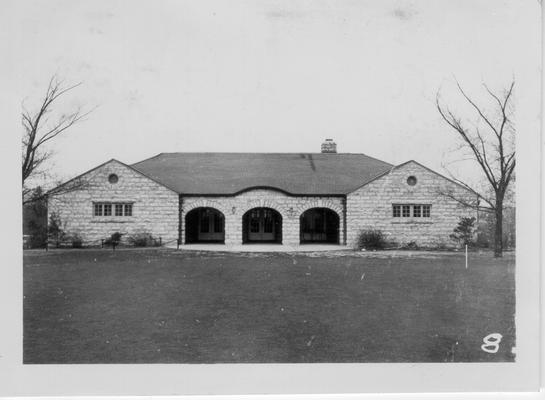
[346,161,476,246]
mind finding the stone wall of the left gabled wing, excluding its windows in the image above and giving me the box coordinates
[48,160,179,243]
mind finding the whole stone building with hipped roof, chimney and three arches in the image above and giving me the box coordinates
[48,139,475,246]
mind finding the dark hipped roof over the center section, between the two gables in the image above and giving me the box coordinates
[131,153,393,195]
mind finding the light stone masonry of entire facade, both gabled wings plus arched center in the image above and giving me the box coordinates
[48,160,475,246]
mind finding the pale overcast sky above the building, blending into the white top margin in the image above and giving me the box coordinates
[0,0,541,184]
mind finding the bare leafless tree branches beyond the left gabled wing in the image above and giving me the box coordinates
[22,75,91,204]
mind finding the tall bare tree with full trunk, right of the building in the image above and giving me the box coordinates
[436,79,516,257]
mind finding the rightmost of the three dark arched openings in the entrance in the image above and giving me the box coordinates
[299,208,340,244]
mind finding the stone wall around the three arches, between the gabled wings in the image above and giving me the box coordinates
[181,189,344,245]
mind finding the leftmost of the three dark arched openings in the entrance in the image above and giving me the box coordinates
[185,207,225,244]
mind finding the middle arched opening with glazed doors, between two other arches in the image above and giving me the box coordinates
[242,208,282,243]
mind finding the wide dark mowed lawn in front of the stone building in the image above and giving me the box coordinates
[24,249,515,363]
